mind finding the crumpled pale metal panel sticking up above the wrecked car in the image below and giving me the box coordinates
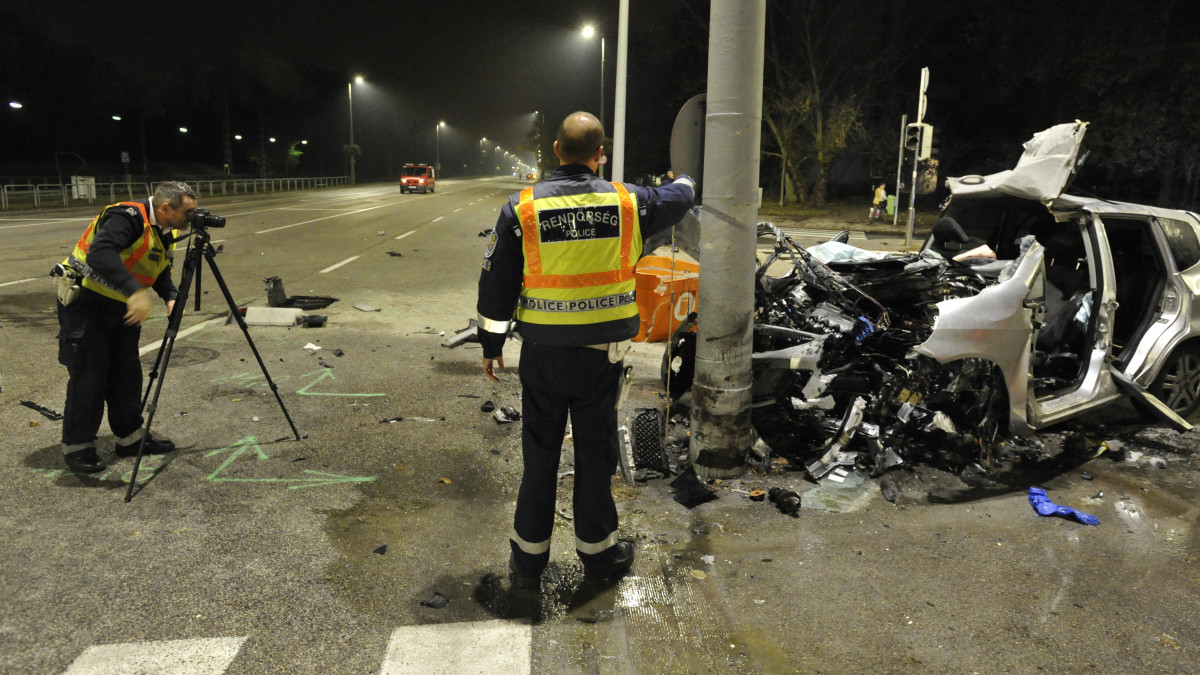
[946,120,1087,202]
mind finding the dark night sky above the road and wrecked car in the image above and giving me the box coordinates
[7,0,1200,207]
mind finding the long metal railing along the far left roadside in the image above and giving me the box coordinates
[0,175,350,210]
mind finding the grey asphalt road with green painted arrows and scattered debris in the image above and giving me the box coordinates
[0,179,1200,674]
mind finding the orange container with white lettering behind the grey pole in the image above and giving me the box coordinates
[634,256,700,342]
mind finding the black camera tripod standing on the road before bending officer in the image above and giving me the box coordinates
[125,228,300,502]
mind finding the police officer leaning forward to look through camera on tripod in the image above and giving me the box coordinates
[56,181,197,473]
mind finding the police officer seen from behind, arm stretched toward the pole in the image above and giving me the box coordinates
[478,112,695,589]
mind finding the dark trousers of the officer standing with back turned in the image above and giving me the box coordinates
[510,342,622,575]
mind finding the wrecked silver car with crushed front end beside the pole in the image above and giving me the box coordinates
[664,121,1200,478]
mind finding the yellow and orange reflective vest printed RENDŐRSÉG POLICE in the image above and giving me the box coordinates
[516,183,642,325]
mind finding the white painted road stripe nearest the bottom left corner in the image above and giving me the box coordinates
[64,638,246,675]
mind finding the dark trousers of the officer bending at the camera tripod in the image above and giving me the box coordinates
[59,299,143,452]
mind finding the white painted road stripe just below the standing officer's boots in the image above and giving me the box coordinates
[379,620,533,675]
